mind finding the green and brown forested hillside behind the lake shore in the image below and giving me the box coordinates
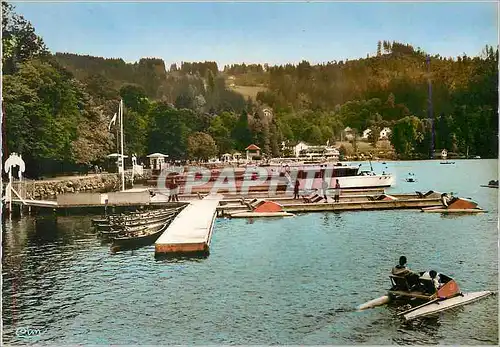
[2,2,498,176]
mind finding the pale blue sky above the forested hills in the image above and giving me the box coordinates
[13,2,498,68]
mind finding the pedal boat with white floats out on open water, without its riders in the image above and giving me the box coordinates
[358,272,494,321]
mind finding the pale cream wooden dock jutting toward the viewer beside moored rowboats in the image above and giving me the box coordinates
[155,194,222,256]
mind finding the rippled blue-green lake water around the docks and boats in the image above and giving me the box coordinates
[3,160,498,345]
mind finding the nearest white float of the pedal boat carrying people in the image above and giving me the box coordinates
[403,290,493,321]
